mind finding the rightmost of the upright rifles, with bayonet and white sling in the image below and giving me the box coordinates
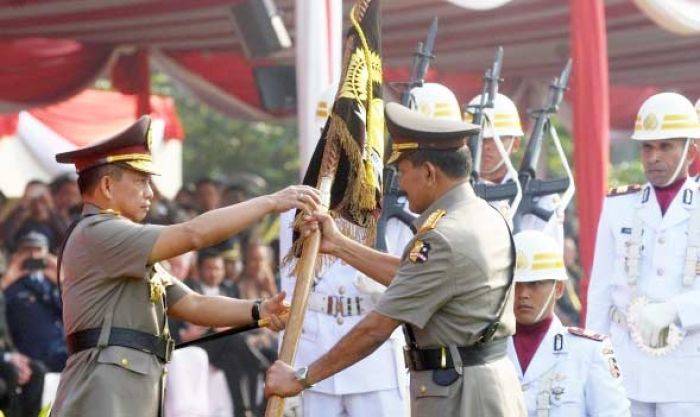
[513,59,573,233]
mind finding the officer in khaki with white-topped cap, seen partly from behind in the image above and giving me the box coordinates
[266,103,525,417]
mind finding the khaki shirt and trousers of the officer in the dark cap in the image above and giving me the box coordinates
[51,204,191,417]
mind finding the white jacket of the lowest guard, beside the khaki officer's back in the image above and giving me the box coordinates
[508,316,630,417]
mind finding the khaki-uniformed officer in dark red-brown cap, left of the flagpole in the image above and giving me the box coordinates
[51,116,319,417]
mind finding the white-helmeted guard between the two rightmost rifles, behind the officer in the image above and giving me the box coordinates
[464,93,564,246]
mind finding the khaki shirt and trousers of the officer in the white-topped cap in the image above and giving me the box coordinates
[375,182,524,417]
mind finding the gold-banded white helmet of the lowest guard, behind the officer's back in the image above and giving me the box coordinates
[513,230,568,282]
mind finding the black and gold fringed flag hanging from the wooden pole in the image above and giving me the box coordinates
[296,0,384,244]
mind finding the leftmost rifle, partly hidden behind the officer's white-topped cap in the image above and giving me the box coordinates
[375,17,438,252]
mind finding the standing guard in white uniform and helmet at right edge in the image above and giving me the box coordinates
[587,93,700,417]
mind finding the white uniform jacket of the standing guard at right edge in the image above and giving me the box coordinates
[586,178,700,402]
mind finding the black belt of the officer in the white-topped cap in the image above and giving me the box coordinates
[403,339,507,371]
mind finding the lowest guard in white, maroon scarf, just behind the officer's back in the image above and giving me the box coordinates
[508,230,630,417]
